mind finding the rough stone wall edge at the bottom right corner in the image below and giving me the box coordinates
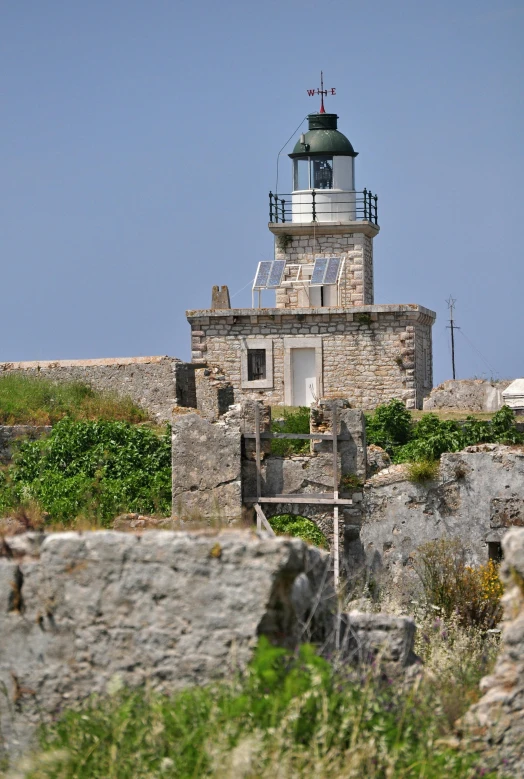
[462,528,524,777]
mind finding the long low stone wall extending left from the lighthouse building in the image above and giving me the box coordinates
[0,357,196,422]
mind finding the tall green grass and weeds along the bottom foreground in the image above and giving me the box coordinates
[27,639,500,779]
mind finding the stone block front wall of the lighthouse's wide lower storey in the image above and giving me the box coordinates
[187,305,435,409]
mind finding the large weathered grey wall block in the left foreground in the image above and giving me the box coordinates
[0,531,334,754]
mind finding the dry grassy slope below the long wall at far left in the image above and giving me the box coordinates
[0,374,149,425]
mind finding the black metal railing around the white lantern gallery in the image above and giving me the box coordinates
[269,189,378,224]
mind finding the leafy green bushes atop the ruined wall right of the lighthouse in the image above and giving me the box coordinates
[366,399,524,463]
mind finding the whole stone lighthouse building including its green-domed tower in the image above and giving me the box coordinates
[187,104,435,409]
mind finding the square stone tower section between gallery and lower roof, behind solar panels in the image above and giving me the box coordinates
[275,233,374,308]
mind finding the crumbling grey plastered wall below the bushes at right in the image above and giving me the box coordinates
[359,444,524,577]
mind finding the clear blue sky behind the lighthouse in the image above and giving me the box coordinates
[0,0,524,383]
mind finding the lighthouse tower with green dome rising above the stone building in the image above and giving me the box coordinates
[269,113,380,308]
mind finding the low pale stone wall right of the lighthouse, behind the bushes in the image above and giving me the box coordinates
[424,379,511,411]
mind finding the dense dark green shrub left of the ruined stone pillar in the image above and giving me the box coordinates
[0,418,171,525]
